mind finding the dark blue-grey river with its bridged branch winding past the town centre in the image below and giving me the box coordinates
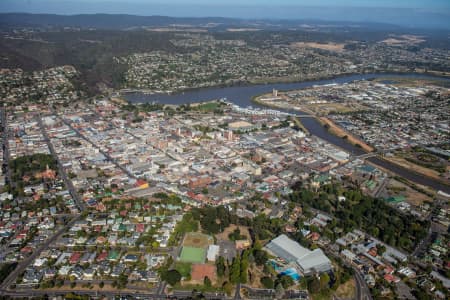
[123,73,450,193]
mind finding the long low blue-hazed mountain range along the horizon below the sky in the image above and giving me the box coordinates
[0,13,408,30]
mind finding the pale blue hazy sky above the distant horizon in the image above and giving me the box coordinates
[0,0,450,29]
